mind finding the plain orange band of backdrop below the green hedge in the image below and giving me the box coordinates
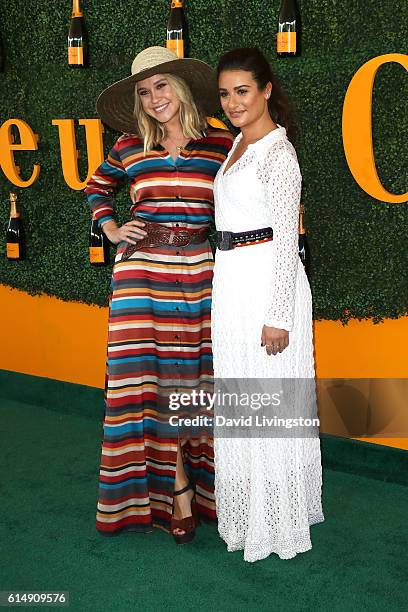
[0,285,408,448]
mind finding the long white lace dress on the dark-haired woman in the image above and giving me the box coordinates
[212,126,324,561]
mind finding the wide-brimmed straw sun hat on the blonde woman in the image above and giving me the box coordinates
[96,47,219,134]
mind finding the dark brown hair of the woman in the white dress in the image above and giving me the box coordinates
[217,47,298,143]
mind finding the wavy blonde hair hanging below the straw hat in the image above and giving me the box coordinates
[134,73,207,153]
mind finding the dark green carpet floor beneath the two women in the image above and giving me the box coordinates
[0,399,408,612]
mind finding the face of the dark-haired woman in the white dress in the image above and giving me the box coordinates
[218,70,272,130]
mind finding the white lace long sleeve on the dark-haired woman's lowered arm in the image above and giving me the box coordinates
[260,140,302,331]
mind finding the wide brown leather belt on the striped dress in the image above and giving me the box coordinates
[121,221,208,261]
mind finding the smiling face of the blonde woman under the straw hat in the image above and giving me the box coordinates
[137,74,180,123]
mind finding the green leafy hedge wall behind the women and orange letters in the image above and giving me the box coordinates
[0,0,408,321]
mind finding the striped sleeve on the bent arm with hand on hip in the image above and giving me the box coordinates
[85,136,127,227]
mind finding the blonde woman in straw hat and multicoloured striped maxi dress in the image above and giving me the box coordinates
[86,47,232,543]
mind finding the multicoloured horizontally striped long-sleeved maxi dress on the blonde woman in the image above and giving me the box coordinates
[85,128,233,535]
